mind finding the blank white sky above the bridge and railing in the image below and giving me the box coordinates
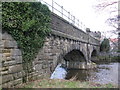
[39,0,116,37]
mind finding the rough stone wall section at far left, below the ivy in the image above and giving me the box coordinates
[0,32,24,87]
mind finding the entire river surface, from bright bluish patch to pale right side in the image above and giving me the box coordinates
[51,63,120,85]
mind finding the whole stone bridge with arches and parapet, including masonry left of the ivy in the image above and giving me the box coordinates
[0,13,100,87]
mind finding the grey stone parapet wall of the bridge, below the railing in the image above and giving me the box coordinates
[51,13,99,45]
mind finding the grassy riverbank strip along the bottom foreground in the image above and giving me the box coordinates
[16,79,117,88]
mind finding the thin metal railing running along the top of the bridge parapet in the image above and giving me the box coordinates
[39,0,86,32]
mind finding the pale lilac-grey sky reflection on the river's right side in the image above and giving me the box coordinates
[94,63,119,84]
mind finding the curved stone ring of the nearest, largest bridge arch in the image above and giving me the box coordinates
[53,41,87,71]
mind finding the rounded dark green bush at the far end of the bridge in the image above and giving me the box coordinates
[100,38,110,52]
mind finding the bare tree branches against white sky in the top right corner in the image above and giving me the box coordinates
[96,0,120,33]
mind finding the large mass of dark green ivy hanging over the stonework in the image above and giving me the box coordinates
[2,2,50,82]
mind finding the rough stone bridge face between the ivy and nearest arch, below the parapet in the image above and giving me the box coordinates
[33,35,87,76]
